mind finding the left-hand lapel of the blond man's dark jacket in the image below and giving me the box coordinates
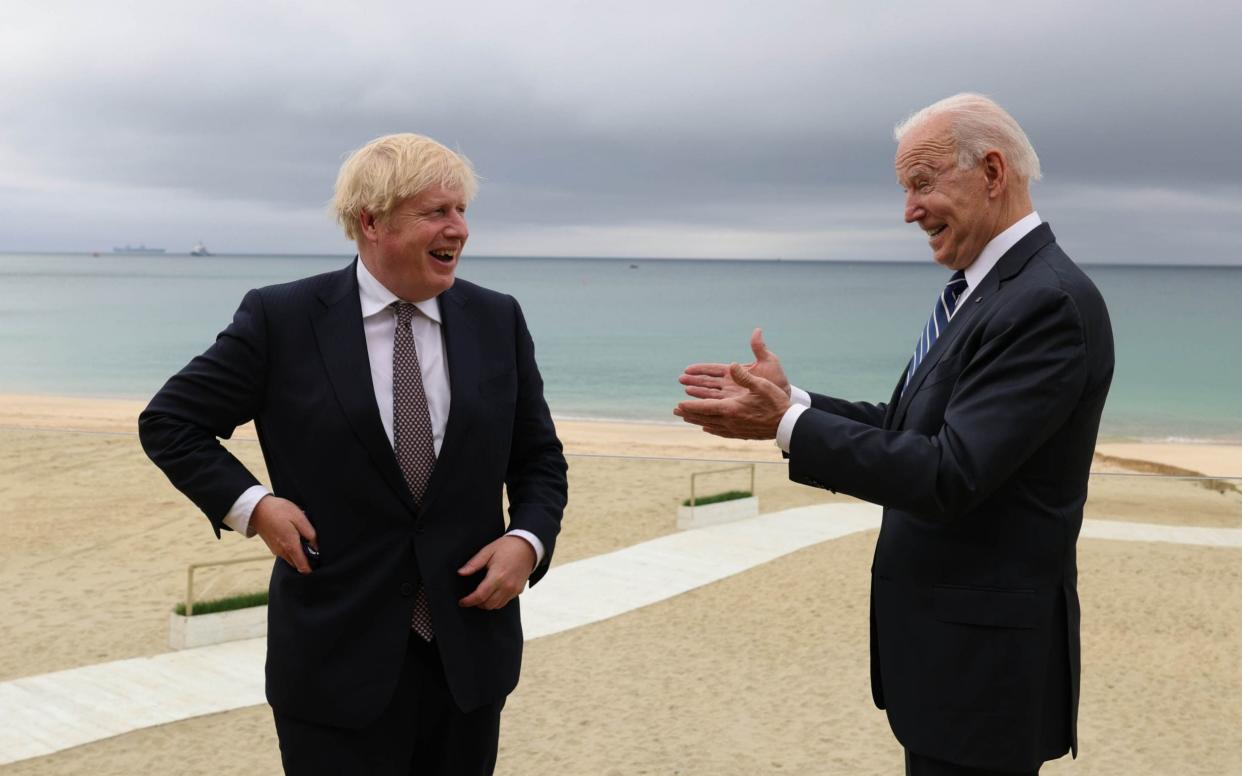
[312,259,415,512]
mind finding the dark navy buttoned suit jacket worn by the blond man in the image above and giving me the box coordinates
[139,264,566,726]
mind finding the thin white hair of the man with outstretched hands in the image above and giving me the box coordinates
[893,92,1041,181]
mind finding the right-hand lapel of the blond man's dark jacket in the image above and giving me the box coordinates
[422,284,479,509]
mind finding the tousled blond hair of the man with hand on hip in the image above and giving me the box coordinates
[332,132,478,241]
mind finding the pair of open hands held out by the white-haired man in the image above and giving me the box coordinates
[673,329,790,440]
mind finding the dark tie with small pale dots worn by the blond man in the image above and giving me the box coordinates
[391,302,436,641]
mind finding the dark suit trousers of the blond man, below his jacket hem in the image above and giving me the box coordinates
[273,631,504,776]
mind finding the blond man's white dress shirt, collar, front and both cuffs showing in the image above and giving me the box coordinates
[224,258,544,566]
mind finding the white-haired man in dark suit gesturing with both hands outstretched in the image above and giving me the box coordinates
[676,94,1113,776]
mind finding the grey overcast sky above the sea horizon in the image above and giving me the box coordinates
[0,0,1242,264]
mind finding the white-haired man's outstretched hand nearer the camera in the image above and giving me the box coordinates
[673,360,790,440]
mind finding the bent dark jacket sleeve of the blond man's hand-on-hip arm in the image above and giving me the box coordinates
[138,291,266,538]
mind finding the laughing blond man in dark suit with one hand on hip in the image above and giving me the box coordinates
[139,134,566,776]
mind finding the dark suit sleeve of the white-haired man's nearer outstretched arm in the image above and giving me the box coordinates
[790,287,1089,519]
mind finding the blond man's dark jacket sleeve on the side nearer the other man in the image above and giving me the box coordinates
[504,295,569,585]
